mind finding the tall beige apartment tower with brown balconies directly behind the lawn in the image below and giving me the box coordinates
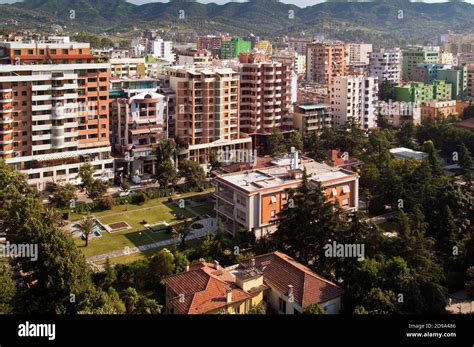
[168,66,252,164]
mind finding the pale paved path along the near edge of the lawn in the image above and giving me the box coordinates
[87,218,217,263]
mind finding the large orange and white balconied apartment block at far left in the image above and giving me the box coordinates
[0,37,114,190]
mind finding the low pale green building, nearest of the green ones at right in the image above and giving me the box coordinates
[395,81,452,104]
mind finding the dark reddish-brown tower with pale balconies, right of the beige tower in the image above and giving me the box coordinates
[239,54,292,135]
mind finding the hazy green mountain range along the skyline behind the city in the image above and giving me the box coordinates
[0,0,474,44]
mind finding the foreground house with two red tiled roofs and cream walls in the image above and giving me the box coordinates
[165,252,344,314]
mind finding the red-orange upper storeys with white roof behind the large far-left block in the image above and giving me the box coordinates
[0,36,96,65]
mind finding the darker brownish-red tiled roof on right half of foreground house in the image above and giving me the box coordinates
[242,252,344,307]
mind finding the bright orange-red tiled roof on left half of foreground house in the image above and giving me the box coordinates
[165,263,252,314]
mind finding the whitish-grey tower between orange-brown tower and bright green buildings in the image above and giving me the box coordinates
[369,49,402,85]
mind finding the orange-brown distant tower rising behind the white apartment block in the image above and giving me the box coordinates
[306,43,346,84]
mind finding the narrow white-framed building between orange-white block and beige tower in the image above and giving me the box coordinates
[110,78,167,177]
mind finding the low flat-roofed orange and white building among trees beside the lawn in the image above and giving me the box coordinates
[215,155,359,238]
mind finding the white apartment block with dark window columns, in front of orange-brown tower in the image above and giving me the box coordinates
[330,76,379,129]
